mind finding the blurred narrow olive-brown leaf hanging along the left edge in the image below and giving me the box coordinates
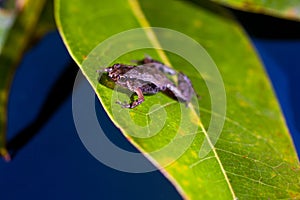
[0,0,46,160]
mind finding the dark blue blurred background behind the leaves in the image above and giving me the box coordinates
[0,9,300,199]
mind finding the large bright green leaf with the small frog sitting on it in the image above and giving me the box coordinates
[55,0,300,199]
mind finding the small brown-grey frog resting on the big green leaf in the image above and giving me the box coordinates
[101,56,195,109]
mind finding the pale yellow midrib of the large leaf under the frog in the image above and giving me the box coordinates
[128,0,237,199]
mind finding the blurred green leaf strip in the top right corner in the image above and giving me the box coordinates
[212,0,300,20]
